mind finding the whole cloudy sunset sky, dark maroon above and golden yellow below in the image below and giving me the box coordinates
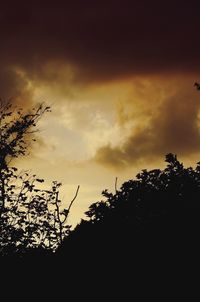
[0,0,200,224]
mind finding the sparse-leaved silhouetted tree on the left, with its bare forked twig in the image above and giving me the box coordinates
[0,102,79,255]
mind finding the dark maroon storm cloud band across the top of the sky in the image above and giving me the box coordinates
[0,0,200,89]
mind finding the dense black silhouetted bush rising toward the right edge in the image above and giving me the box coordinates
[60,153,200,263]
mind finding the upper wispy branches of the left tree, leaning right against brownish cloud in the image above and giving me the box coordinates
[0,101,50,169]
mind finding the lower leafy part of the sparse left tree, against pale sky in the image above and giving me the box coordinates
[0,168,70,254]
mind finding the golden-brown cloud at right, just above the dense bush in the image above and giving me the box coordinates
[94,78,200,168]
